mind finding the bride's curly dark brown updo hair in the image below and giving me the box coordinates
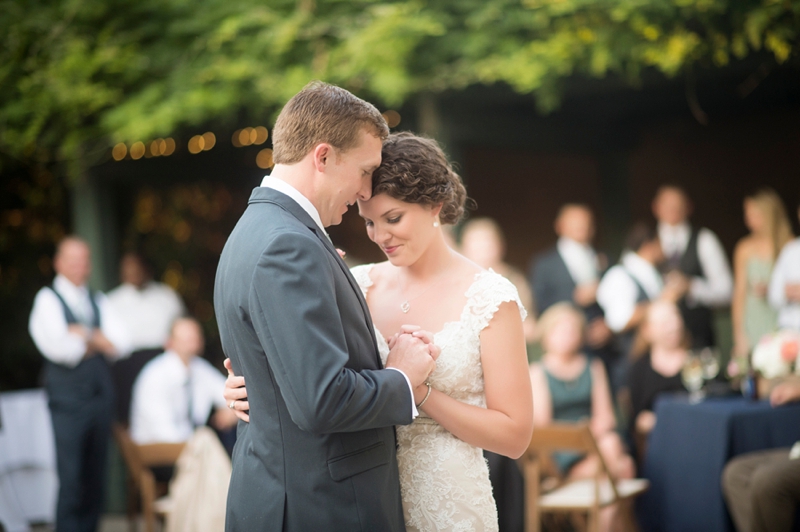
[372,132,467,225]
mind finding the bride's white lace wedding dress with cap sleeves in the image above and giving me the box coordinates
[352,264,526,532]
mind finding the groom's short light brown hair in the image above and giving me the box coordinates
[272,81,389,164]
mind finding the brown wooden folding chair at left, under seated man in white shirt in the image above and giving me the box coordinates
[113,424,186,532]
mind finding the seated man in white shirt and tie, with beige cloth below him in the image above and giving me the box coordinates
[130,318,237,532]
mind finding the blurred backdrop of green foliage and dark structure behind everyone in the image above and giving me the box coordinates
[0,0,800,391]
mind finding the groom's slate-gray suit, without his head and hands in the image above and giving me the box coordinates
[214,187,413,532]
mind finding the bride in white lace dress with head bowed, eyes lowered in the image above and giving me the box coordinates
[225,133,533,531]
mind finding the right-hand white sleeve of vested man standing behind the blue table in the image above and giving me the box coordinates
[687,229,733,307]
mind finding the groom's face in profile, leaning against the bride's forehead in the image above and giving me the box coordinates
[319,130,383,227]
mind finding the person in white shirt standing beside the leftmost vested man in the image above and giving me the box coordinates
[108,252,185,425]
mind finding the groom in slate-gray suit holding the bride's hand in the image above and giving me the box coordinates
[214,82,438,532]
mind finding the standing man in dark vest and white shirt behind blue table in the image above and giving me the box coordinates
[652,185,733,347]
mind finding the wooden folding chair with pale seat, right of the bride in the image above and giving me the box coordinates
[520,423,649,532]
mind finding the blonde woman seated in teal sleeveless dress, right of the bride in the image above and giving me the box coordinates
[530,303,634,525]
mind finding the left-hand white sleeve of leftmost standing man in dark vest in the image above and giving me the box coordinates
[28,288,86,367]
